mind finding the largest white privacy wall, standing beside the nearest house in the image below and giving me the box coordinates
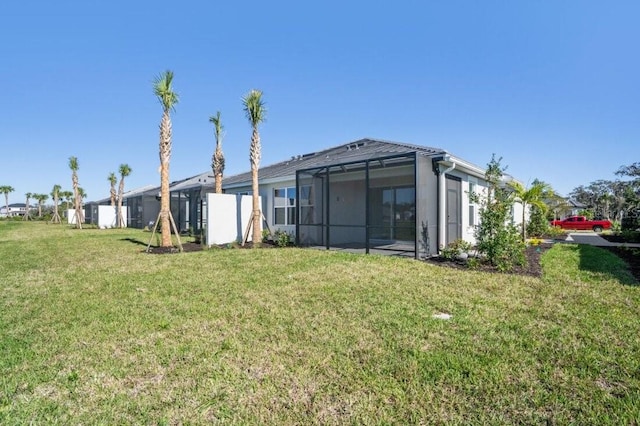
[206,194,262,246]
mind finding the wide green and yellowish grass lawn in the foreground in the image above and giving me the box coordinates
[0,221,640,425]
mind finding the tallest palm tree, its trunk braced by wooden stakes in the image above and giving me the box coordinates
[153,70,178,247]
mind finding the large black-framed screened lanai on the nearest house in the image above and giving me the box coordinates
[295,152,417,257]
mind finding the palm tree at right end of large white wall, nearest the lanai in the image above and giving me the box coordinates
[242,89,267,247]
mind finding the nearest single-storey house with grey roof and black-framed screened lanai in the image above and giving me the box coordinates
[222,139,522,257]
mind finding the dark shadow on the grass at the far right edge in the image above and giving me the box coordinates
[573,244,639,286]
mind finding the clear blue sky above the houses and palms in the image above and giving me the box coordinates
[0,0,640,204]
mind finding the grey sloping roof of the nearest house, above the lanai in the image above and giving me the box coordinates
[222,138,446,186]
